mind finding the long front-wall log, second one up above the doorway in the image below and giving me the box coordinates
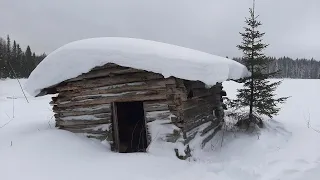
[58,78,175,100]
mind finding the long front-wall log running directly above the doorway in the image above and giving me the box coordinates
[56,93,166,108]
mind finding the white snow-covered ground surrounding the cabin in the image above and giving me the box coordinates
[0,80,320,180]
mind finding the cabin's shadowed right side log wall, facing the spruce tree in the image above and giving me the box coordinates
[182,80,223,144]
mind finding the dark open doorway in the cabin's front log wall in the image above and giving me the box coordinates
[114,102,147,153]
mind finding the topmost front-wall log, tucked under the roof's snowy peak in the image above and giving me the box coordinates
[66,66,143,82]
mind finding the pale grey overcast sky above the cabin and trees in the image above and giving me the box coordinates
[0,0,320,60]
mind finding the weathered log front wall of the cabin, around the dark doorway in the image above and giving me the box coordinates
[51,64,176,150]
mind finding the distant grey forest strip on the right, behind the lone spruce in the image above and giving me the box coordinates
[234,57,320,79]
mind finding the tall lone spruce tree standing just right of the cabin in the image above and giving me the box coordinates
[231,0,287,125]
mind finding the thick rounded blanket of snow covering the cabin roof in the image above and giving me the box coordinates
[25,37,249,96]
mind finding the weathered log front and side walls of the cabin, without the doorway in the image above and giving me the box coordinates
[47,64,223,155]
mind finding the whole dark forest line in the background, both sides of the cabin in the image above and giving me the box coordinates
[0,36,320,79]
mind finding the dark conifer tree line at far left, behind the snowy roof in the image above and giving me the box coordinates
[0,35,46,78]
